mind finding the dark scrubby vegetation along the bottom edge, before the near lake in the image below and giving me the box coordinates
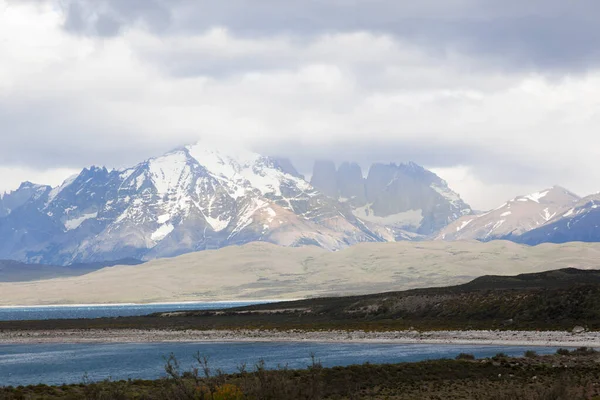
[0,348,600,400]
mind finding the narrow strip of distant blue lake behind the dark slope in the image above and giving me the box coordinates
[0,301,268,321]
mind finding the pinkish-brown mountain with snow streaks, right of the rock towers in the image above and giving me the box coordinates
[436,186,580,241]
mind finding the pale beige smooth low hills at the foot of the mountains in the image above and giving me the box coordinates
[0,241,600,305]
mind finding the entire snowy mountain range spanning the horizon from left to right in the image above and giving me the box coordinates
[0,142,600,265]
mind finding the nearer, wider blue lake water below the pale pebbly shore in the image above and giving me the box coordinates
[0,343,556,386]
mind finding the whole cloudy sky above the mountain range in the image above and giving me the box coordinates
[0,0,600,210]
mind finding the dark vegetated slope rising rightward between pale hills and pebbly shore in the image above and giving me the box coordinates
[0,268,600,330]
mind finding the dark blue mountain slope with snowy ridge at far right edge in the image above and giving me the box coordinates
[514,194,600,245]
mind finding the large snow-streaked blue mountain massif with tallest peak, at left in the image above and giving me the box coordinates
[0,143,394,264]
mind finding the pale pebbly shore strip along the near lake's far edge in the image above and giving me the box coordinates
[0,329,600,347]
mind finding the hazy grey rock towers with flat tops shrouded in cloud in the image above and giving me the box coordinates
[311,161,472,240]
